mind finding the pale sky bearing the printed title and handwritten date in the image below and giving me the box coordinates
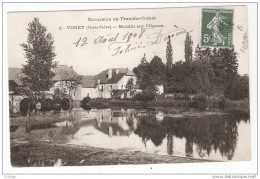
[7,6,248,75]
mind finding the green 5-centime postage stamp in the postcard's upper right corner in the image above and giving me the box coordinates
[201,8,233,47]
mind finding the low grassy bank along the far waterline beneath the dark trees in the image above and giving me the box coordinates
[90,98,249,109]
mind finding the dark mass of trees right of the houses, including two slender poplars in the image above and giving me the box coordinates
[134,39,246,103]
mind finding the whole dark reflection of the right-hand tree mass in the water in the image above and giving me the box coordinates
[135,112,249,160]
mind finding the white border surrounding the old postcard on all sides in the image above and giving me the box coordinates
[1,0,257,177]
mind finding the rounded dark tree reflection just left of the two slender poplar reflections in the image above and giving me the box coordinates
[135,117,166,146]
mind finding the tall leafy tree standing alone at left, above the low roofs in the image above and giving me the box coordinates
[21,18,56,92]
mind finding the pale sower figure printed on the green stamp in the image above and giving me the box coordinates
[207,11,227,45]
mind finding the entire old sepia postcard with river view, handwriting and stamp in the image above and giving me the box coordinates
[7,6,251,168]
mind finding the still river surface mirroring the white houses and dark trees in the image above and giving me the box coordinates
[11,109,250,160]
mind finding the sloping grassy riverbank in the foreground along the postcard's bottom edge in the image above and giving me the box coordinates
[11,140,216,167]
